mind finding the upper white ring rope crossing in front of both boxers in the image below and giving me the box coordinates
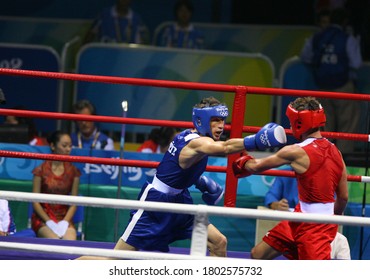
[0,191,370,226]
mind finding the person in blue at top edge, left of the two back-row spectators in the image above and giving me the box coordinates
[85,0,150,44]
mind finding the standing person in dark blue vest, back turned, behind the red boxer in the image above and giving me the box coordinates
[301,9,362,156]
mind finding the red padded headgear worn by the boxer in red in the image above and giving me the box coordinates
[285,104,326,140]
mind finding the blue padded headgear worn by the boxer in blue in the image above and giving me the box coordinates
[193,105,229,137]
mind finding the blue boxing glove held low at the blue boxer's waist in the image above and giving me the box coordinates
[194,176,224,205]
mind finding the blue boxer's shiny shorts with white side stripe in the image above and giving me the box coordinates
[121,183,194,252]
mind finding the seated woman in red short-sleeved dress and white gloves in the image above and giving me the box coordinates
[32,131,81,240]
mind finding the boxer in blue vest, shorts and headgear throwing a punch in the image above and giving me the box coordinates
[77,97,286,259]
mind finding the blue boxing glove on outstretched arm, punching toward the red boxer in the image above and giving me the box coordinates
[244,123,287,151]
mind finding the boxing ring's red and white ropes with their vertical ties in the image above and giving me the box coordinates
[0,69,370,259]
